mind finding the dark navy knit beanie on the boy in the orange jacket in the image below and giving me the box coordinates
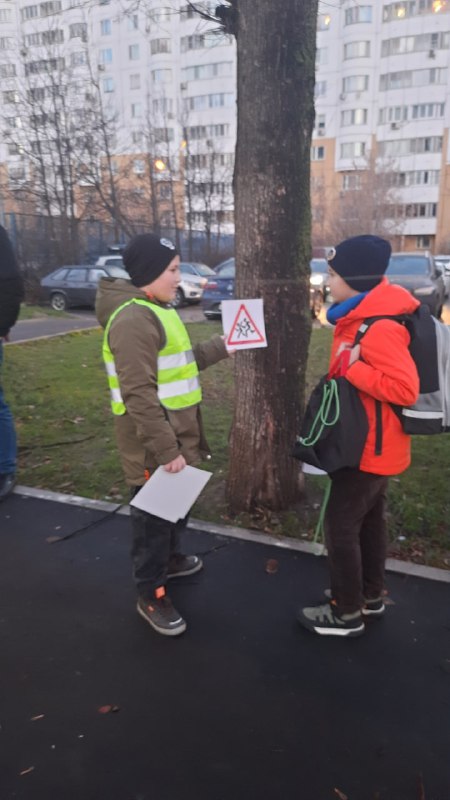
[328,236,392,292]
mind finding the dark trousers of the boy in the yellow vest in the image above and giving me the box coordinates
[130,487,188,599]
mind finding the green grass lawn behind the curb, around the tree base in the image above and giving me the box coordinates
[4,323,450,568]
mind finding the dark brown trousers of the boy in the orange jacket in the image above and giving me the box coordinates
[325,469,388,614]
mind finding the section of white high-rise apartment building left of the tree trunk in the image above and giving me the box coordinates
[0,0,236,232]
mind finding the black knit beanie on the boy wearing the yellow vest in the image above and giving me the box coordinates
[122,233,178,286]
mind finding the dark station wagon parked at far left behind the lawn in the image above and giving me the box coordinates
[41,264,130,311]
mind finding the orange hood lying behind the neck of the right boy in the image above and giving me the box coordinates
[338,278,420,327]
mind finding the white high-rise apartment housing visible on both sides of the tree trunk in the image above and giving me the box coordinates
[0,0,450,252]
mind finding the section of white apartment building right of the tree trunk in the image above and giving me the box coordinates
[311,0,450,252]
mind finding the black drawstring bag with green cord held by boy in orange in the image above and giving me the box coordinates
[292,376,369,473]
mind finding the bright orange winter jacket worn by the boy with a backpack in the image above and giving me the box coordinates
[330,278,419,475]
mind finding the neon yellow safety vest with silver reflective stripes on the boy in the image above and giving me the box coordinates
[103,298,202,416]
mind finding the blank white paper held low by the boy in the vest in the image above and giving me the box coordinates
[130,467,212,522]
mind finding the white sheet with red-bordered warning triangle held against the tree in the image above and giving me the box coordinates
[222,298,267,350]
